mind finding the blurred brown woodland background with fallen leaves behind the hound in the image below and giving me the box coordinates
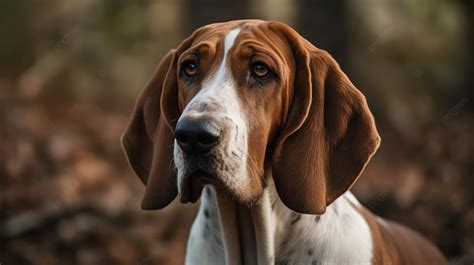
[0,0,474,265]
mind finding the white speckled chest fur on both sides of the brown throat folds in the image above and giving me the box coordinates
[186,187,373,265]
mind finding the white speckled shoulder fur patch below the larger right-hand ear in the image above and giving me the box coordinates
[276,192,373,265]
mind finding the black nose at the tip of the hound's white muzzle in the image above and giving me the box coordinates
[174,118,221,155]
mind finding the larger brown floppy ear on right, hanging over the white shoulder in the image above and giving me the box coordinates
[272,21,380,214]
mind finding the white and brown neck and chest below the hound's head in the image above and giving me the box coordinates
[187,175,372,264]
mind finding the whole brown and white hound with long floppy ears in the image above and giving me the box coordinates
[122,20,447,265]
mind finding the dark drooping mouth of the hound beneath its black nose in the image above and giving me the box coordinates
[179,169,220,203]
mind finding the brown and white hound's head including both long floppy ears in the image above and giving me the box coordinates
[122,20,380,214]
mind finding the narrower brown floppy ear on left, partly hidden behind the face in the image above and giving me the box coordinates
[121,32,197,210]
